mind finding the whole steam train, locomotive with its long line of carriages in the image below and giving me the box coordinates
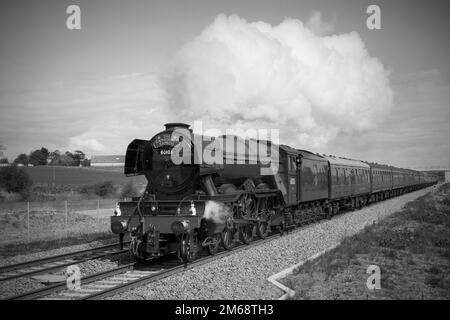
[111,123,437,263]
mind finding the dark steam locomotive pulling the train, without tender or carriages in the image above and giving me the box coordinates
[111,123,282,261]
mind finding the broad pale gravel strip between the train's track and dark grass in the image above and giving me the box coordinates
[108,187,435,300]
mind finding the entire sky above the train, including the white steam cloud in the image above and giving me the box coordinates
[0,0,450,168]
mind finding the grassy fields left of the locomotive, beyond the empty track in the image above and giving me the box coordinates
[0,166,146,257]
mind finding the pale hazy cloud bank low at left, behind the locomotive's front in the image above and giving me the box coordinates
[0,74,168,158]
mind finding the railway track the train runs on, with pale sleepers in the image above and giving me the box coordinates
[6,232,284,300]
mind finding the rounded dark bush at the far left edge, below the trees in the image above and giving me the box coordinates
[0,166,33,198]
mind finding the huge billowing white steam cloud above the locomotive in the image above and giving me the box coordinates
[163,12,393,148]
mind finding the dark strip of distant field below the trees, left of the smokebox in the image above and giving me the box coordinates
[24,166,146,185]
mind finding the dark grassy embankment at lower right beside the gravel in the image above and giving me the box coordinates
[282,184,450,299]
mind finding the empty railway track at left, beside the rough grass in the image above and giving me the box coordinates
[0,242,129,282]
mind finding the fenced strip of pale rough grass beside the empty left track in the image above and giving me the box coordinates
[0,199,119,245]
